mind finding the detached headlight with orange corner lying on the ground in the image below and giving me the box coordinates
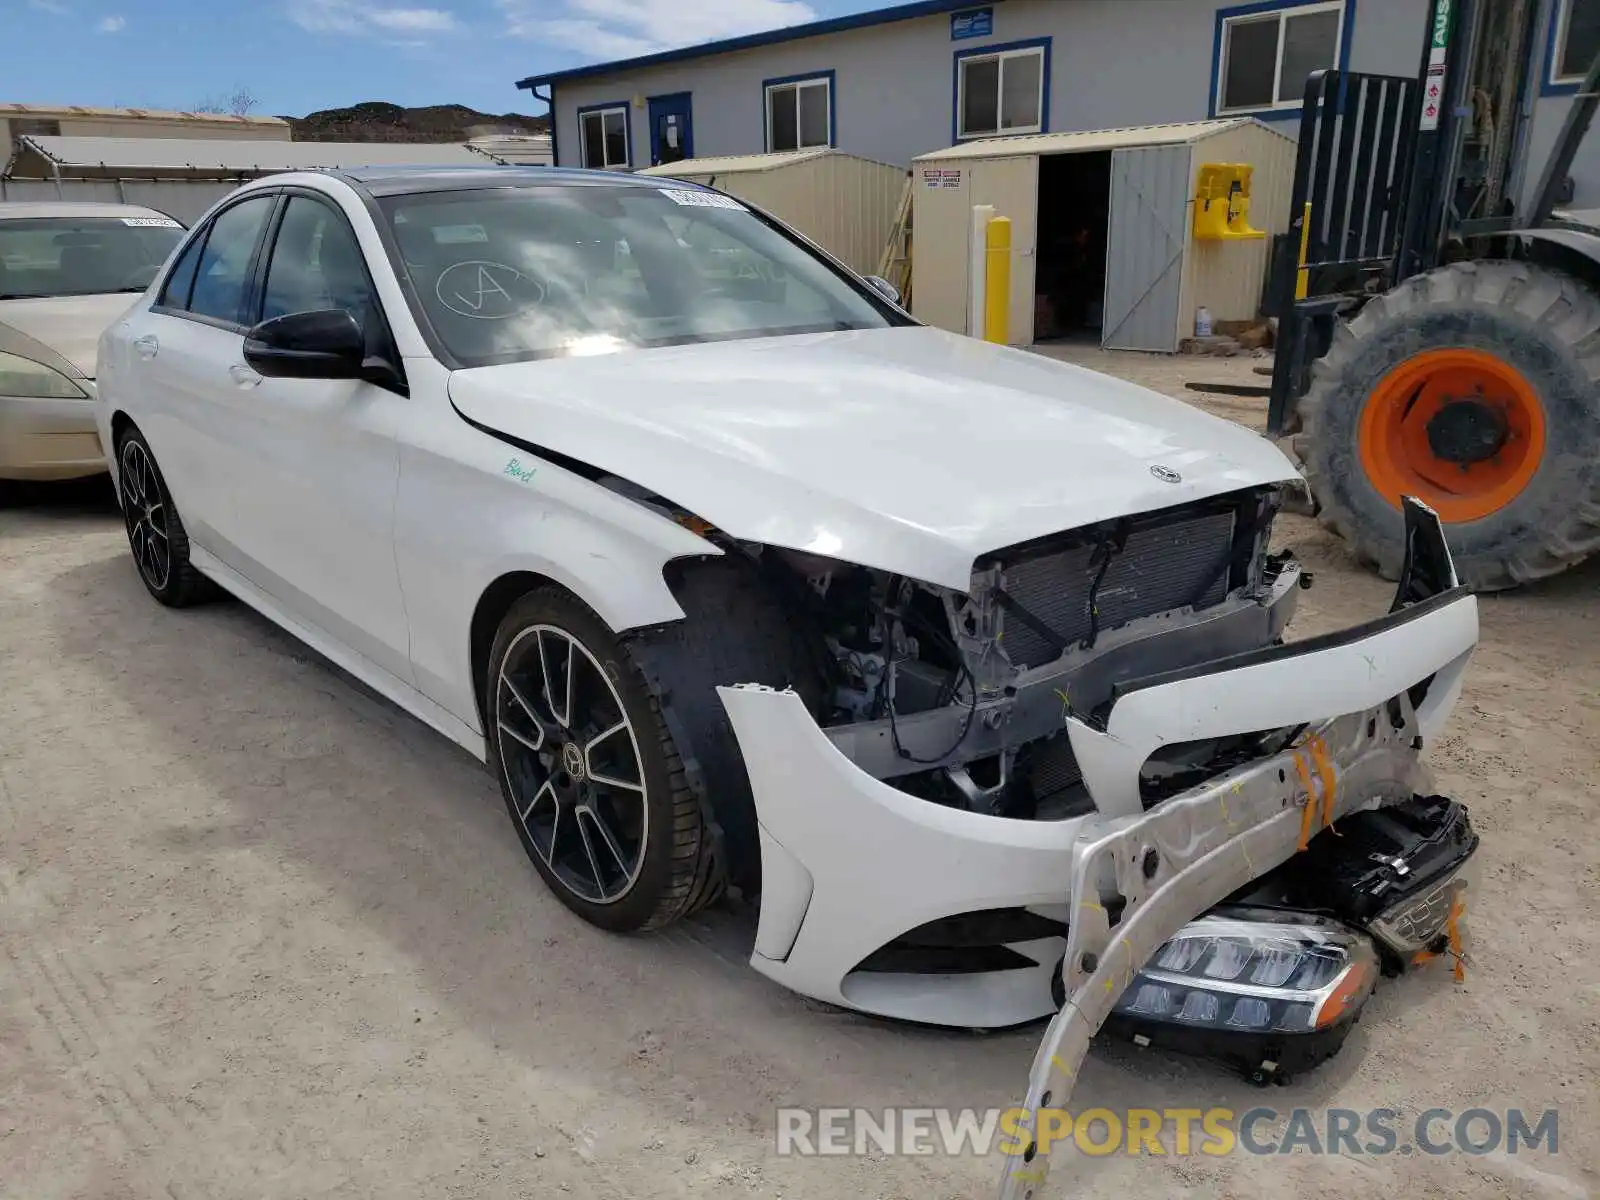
[1117,909,1378,1034]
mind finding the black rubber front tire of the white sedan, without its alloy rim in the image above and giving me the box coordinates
[483,586,723,933]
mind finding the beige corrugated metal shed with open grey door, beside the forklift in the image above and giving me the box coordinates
[912,117,1294,352]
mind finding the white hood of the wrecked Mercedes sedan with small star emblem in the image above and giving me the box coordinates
[450,326,1296,590]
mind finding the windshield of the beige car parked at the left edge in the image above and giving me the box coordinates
[0,214,184,301]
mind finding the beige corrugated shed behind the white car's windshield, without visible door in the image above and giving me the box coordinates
[635,147,906,275]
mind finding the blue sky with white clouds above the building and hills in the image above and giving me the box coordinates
[0,0,893,117]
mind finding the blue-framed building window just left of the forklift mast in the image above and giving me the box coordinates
[1216,0,1344,114]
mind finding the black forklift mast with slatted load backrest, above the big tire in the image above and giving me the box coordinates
[1264,0,1600,437]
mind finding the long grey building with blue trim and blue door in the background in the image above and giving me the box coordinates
[518,0,1600,203]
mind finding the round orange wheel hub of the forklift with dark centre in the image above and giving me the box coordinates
[1357,349,1546,522]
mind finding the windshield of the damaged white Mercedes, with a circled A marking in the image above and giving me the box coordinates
[382,182,904,366]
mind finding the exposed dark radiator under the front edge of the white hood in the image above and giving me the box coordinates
[998,512,1235,667]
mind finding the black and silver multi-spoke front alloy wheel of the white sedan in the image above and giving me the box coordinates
[494,624,650,904]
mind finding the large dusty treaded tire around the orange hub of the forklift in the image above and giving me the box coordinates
[1294,261,1600,592]
